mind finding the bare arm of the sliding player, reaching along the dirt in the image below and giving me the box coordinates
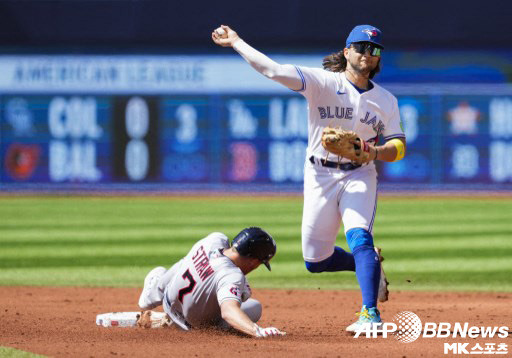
[220,300,286,338]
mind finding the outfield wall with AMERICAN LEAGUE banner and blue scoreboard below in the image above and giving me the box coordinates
[0,55,512,191]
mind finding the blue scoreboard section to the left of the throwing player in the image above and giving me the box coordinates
[0,95,307,183]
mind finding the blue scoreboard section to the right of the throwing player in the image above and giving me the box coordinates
[380,94,512,184]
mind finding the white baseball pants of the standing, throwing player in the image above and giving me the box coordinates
[302,160,377,262]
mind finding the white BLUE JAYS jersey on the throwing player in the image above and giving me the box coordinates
[296,66,405,163]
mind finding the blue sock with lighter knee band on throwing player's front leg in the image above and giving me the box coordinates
[346,228,380,308]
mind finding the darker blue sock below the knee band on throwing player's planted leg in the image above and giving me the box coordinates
[353,245,380,308]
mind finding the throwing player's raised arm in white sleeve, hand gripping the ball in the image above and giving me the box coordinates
[212,25,302,91]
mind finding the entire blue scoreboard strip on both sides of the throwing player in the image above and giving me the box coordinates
[4,94,512,183]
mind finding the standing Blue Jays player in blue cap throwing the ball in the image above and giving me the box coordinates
[212,25,405,332]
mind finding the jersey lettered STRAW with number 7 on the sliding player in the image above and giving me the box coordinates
[163,232,251,329]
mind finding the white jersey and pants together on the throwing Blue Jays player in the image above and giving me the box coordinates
[296,67,405,262]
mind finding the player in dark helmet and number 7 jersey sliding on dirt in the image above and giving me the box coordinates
[139,227,285,337]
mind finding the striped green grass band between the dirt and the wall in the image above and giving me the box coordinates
[0,197,512,291]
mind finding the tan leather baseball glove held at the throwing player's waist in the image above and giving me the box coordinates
[322,127,370,164]
